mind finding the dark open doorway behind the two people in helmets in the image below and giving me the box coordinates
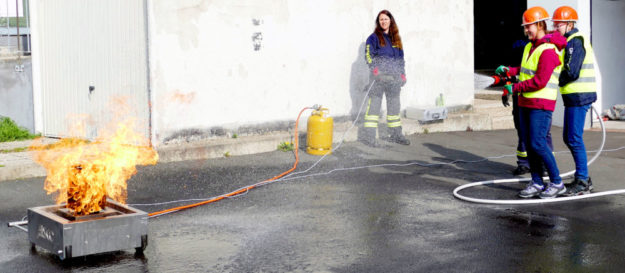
[473,0,527,72]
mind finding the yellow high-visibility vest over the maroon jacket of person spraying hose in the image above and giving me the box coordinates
[519,43,562,100]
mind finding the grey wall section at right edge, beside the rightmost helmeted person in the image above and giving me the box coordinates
[592,0,625,109]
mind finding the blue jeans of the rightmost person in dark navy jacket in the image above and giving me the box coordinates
[562,105,590,180]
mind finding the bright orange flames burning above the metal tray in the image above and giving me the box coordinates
[31,98,158,215]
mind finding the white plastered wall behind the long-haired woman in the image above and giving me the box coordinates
[148,0,473,144]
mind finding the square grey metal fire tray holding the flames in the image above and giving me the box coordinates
[28,199,148,260]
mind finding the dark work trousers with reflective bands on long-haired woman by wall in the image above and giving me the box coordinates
[364,78,401,130]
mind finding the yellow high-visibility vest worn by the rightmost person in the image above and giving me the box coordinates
[560,32,597,95]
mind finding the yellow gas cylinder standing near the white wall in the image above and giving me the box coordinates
[306,108,334,155]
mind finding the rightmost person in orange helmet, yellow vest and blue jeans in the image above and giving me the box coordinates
[552,6,597,196]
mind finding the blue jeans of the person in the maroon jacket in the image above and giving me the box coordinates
[519,107,562,186]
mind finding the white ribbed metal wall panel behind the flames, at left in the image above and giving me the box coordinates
[31,0,149,138]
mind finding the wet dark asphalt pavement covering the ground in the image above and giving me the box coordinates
[0,128,625,272]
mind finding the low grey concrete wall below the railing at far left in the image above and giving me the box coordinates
[0,57,35,133]
